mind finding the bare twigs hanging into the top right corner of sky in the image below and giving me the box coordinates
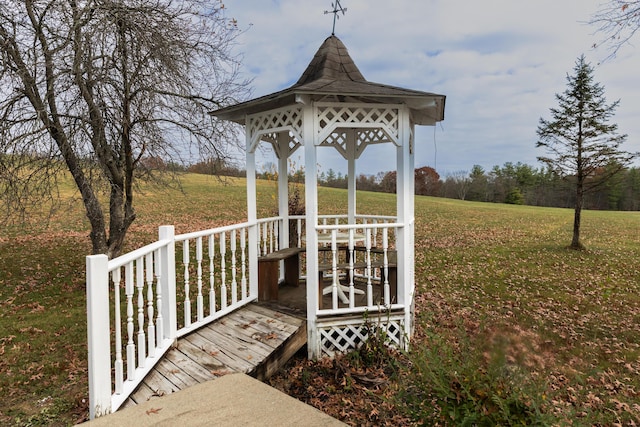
[589,0,640,59]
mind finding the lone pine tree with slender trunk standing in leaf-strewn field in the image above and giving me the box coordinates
[536,55,638,249]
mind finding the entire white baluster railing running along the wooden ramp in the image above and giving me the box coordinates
[86,218,281,419]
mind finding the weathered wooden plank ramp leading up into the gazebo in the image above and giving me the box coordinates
[122,303,307,408]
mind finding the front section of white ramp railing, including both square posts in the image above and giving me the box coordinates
[87,227,176,418]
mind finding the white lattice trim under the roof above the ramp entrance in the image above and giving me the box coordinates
[246,107,304,157]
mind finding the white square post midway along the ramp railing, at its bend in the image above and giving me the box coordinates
[158,225,178,341]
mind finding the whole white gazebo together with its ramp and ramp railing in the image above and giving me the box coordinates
[86,35,445,418]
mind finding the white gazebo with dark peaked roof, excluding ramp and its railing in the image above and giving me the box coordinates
[211,35,445,357]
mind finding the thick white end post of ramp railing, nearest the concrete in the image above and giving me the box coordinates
[86,254,111,419]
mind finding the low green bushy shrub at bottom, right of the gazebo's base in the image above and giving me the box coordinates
[396,331,549,426]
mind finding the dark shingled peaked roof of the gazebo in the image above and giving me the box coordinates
[211,35,446,125]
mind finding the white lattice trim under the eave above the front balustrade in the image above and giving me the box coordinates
[316,103,399,144]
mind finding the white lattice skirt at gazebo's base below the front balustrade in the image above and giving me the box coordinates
[318,319,405,357]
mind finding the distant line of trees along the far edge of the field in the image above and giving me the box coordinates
[149,159,640,211]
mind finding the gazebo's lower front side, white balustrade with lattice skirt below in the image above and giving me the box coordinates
[298,215,414,358]
